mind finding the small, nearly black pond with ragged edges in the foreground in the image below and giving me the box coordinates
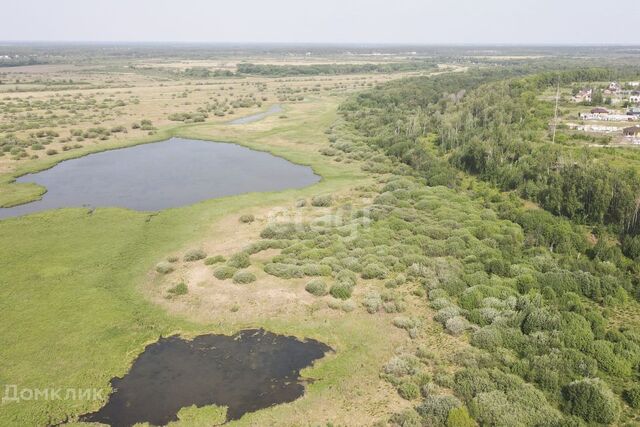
[80,329,331,427]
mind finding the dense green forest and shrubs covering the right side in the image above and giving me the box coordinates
[324,69,640,426]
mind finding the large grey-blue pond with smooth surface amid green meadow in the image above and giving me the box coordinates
[0,138,320,218]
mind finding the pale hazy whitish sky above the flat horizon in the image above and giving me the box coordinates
[0,0,640,44]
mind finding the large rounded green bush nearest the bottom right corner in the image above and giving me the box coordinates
[562,378,619,424]
